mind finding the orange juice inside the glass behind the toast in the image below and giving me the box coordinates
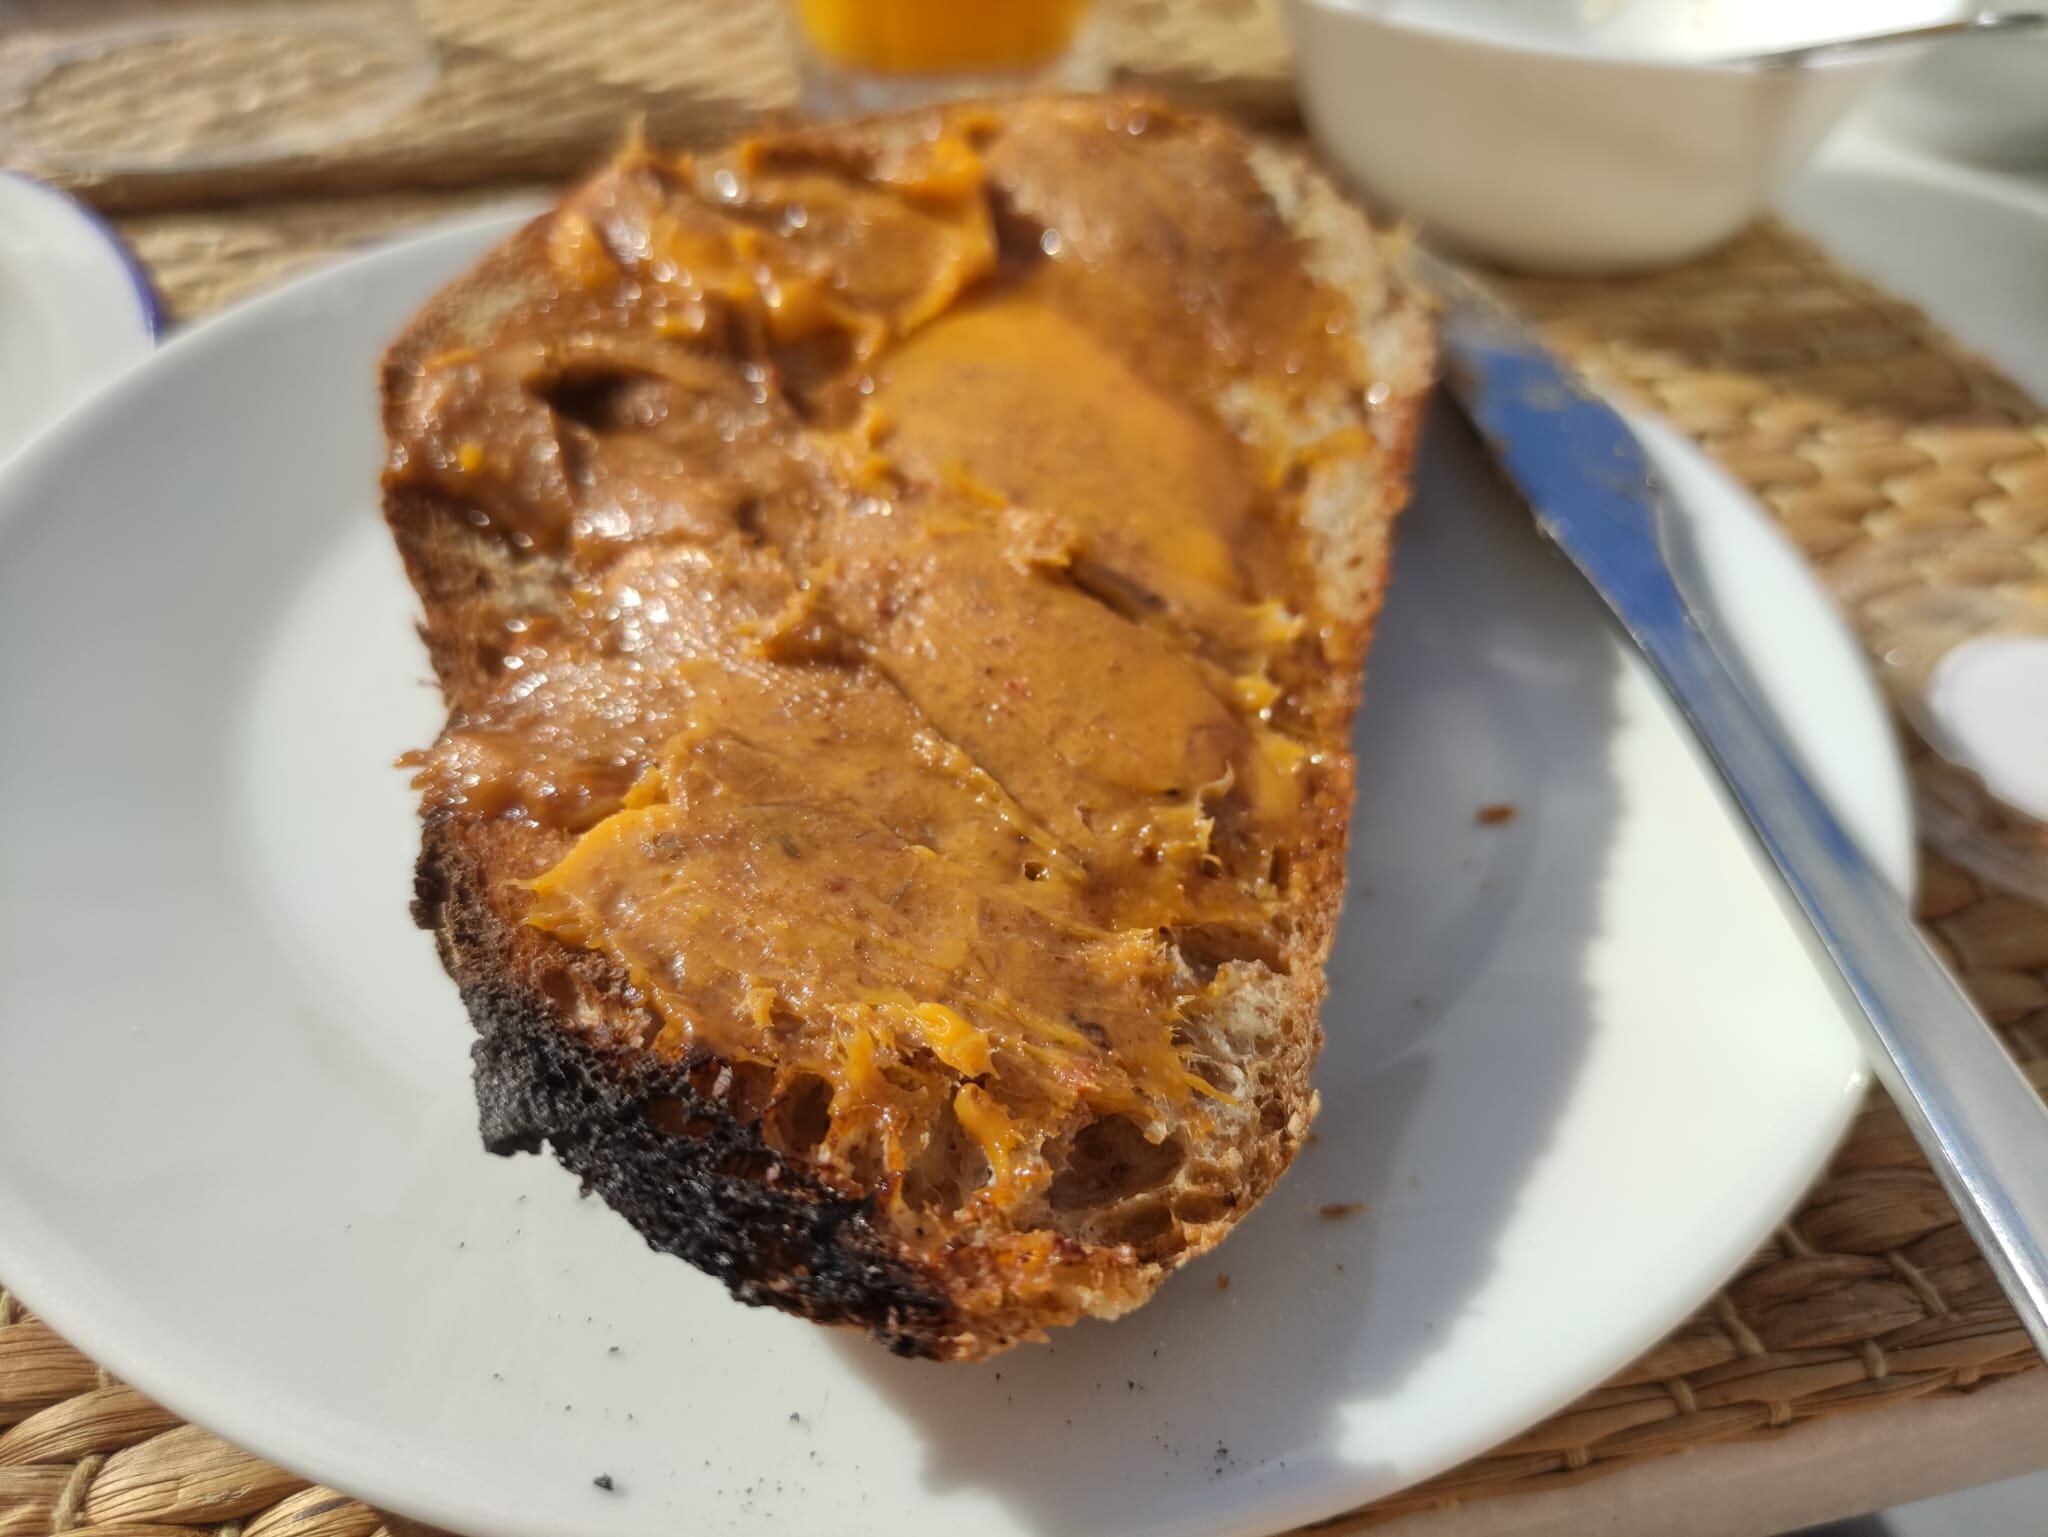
[795,0,1090,76]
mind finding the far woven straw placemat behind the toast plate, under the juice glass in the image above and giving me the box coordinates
[12,0,1294,211]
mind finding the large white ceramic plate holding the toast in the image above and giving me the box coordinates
[0,208,1909,1537]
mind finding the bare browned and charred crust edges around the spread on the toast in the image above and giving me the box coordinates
[385,105,1432,1359]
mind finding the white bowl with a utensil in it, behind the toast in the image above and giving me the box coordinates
[1288,0,1954,273]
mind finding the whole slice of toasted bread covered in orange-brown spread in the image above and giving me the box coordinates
[383,98,1432,1361]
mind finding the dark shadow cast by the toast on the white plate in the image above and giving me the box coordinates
[838,420,1618,1533]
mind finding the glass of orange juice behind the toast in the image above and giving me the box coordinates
[791,0,1102,117]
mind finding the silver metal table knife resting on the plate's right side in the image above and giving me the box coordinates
[1409,250,2048,1355]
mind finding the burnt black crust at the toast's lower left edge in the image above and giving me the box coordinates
[414,846,958,1359]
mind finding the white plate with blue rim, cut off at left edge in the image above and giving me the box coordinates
[0,170,160,463]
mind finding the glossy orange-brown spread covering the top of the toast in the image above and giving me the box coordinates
[389,102,1360,1211]
